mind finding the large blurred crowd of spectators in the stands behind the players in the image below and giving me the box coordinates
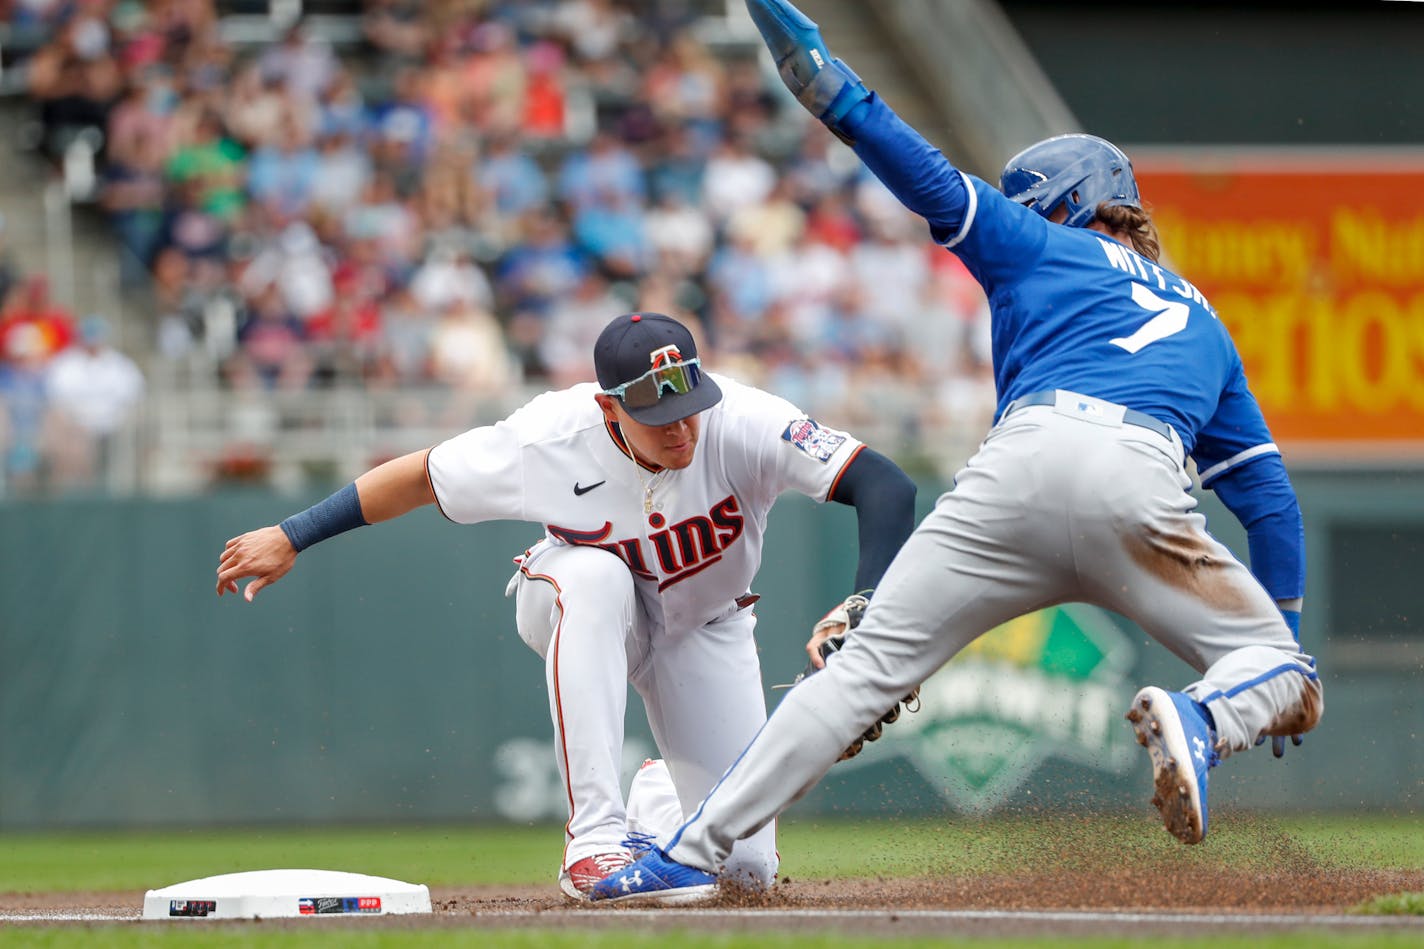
[0,0,993,487]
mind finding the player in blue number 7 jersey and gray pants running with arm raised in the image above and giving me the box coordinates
[583,0,1323,899]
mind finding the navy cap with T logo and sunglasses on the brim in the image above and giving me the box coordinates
[594,313,722,425]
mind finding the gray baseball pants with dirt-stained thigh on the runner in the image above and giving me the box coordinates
[665,393,1323,871]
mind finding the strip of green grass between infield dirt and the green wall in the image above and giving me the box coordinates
[0,815,1424,892]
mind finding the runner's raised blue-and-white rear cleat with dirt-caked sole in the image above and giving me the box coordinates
[1128,685,1220,844]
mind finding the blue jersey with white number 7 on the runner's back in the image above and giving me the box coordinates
[853,95,1279,483]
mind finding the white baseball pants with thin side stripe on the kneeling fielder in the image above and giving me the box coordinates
[511,540,778,885]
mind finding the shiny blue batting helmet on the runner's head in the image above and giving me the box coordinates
[998,134,1142,228]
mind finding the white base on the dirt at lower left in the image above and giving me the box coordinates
[144,869,430,919]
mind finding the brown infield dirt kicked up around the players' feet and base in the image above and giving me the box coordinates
[0,815,1424,932]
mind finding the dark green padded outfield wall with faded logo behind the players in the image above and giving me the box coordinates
[0,473,1424,829]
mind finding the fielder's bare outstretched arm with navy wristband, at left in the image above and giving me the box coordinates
[218,450,436,603]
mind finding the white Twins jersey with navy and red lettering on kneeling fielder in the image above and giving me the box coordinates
[429,375,862,628]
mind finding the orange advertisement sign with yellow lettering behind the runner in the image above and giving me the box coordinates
[1134,151,1424,455]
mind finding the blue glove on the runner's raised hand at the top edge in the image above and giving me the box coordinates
[746,0,870,138]
